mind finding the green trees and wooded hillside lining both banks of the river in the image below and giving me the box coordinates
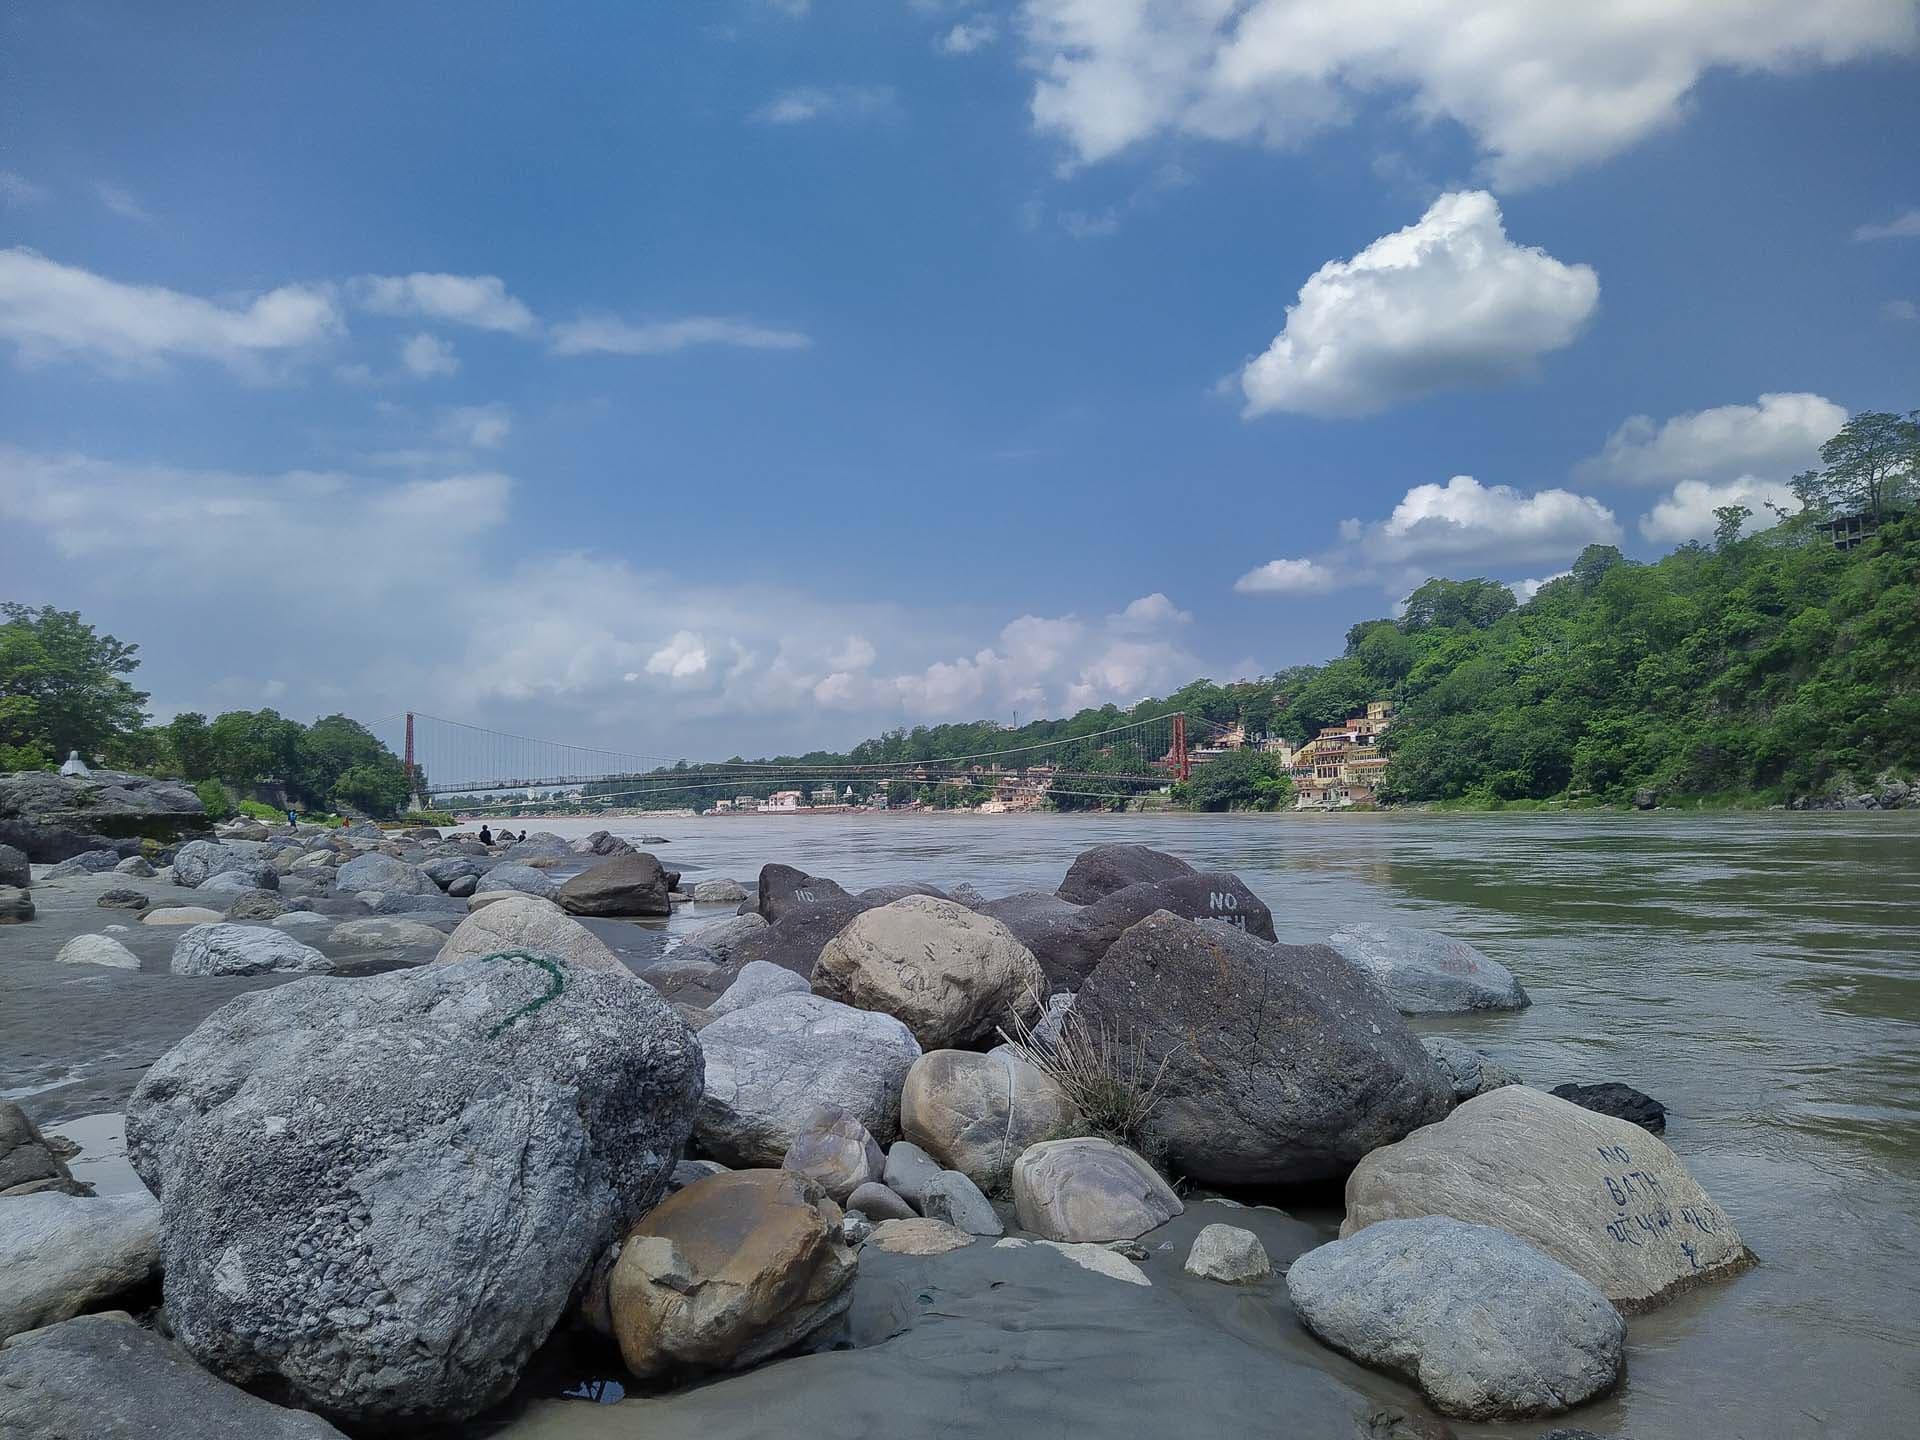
[0,411,1920,824]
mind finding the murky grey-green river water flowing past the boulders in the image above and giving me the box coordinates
[0,814,1920,1440]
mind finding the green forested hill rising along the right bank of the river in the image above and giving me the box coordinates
[795,515,1920,803]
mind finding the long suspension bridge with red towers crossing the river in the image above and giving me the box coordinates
[389,710,1225,810]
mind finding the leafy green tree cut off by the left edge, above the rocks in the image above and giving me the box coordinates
[0,601,146,770]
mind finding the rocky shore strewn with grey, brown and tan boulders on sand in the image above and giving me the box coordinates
[0,806,1753,1438]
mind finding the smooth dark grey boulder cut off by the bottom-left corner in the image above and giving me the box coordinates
[0,1309,346,1440]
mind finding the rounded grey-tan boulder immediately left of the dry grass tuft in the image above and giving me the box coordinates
[900,1046,1079,1192]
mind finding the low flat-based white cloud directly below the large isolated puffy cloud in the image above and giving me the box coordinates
[1235,474,1620,595]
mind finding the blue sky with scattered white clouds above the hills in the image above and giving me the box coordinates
[0,0,1920,758]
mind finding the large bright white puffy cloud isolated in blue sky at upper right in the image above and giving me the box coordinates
[1240,190,1599,417]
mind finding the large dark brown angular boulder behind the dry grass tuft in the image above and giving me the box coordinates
[1073,917,1452,1185]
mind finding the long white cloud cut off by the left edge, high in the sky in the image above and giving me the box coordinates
[0,250,344,378]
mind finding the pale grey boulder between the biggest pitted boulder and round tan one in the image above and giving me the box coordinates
[693,995,920,1165]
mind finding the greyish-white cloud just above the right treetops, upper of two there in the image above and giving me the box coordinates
[1576,392,1847,486]
